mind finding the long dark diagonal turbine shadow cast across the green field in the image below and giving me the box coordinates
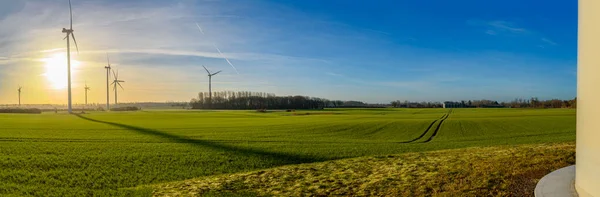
[75,114,326,164]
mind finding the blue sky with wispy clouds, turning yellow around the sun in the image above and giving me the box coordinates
[0,0,577,103]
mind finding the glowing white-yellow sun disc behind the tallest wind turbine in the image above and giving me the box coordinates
[42,53,81,89]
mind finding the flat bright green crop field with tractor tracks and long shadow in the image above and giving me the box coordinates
[0,109,575,196]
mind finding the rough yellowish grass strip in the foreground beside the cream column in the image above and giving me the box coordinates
[146,143,575,196]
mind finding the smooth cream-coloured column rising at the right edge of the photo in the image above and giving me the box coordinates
[575,0,600,197]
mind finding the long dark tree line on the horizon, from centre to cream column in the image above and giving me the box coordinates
[189,91,577,110]
